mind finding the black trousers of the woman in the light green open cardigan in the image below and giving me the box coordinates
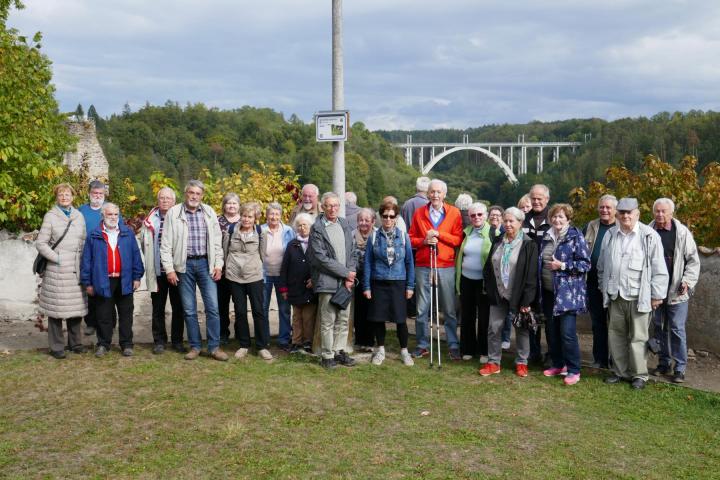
[460,275,490,355]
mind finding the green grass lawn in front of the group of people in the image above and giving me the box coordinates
[0,345,720,479]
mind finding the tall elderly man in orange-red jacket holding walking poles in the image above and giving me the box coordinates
[409,180,463,360]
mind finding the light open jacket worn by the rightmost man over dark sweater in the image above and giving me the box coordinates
[650,218,700,305]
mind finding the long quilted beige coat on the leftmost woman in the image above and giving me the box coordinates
[35,206,87,318]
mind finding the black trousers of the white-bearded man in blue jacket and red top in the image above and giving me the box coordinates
[95,278,134,349]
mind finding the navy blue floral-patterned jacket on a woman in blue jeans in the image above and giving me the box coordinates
[538,226,590,316]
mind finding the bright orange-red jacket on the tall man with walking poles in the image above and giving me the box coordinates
[408,203,463,268]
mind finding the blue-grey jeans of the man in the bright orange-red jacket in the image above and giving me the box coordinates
[415,267,460,349]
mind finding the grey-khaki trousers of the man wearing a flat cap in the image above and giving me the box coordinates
[608,297,652,381]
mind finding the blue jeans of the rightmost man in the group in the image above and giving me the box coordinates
[653,302,688,373]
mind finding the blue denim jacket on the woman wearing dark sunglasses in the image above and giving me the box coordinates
[362,227,415,292]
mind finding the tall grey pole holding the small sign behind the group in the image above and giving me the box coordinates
[332,0,350,217]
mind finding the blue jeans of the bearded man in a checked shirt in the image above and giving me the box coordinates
[178,258,220,352]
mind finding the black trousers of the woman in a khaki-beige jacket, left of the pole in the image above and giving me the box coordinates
[230,280,270,350]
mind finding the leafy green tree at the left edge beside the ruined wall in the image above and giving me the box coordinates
[0,0,76,231]
